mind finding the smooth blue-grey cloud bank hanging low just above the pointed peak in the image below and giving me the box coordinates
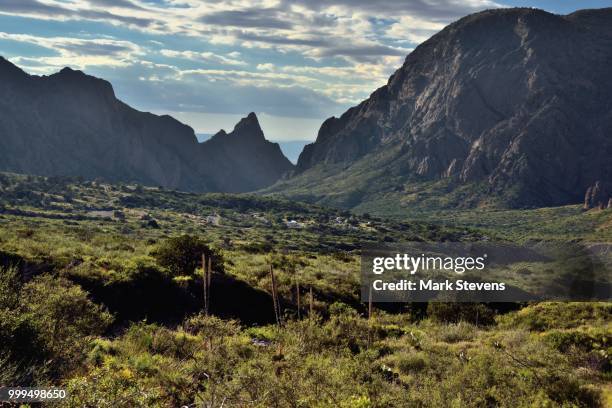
[110,65,346,118]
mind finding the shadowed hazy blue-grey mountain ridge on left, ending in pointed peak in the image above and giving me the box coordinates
[0,57,293,192]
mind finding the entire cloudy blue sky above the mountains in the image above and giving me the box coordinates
[0,0,612,141]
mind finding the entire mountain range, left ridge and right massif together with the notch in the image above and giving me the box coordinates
[0,8,612,211]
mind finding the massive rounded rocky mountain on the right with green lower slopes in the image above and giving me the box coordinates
[268,8,612,208]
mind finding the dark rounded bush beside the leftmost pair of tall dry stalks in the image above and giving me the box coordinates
[152,235,223,275]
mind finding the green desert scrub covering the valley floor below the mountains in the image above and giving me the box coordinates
[0,174,612,408]
